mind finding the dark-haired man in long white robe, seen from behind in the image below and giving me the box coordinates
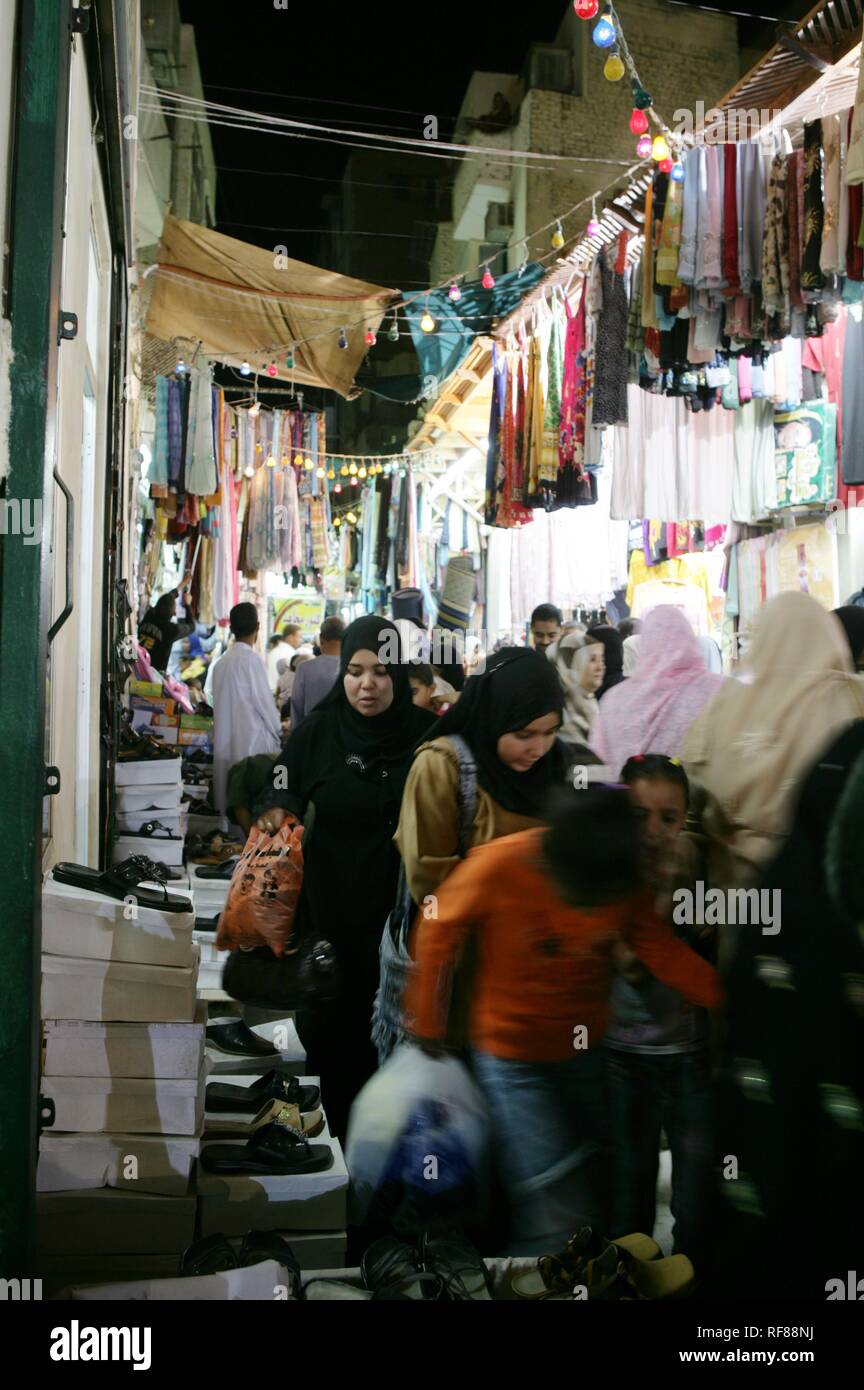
[213,603,282,812]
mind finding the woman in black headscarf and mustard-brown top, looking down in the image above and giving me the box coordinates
[396,646,570,904]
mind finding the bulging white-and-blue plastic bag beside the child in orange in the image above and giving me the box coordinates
[346,1044,489,1236]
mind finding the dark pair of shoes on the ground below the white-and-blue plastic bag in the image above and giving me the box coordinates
[360,1232,492,1302]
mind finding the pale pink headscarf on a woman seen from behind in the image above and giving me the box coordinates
[590,606,722,777]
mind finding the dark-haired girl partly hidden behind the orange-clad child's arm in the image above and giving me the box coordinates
[606,753,713,1269]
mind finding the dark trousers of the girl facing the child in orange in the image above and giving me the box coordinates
[606,1047,713,1265]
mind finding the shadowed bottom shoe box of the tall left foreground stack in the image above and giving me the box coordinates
[36,1187,197,1269]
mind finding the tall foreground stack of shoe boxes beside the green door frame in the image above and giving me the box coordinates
[36,874,207,1277]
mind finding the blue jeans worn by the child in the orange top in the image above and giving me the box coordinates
[472,1048,611,1255]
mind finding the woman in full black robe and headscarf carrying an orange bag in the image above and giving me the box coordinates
[258,616,435,1136]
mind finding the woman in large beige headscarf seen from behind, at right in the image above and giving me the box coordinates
[681,592,864,887]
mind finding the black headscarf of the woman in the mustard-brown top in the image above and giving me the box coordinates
[433,646,567,820]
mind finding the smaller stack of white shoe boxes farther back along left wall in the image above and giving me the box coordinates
[114,756,188,878]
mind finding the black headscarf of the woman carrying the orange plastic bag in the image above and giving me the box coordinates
[315,613,435,776]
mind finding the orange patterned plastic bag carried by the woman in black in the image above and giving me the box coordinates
[217,817,303,955]
